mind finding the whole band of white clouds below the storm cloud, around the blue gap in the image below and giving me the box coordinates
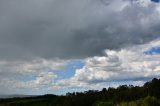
[0,39,160,92]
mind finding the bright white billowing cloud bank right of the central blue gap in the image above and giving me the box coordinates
[54,40,160,88]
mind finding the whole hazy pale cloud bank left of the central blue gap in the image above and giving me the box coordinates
[0,59,68,93]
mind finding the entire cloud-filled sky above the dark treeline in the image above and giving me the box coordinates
[0,0,160,95]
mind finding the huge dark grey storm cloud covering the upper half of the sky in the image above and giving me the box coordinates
[0,0,160,60]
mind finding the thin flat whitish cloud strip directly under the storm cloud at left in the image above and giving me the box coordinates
[0,59,66,75]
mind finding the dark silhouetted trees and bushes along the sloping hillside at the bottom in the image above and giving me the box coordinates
[0,78,160,106]
